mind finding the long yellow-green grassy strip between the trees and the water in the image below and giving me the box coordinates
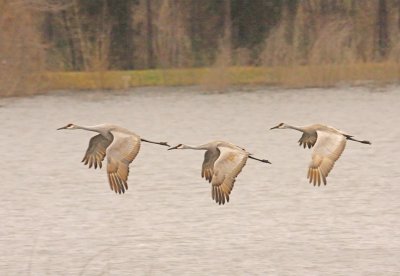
[42,63,400,90]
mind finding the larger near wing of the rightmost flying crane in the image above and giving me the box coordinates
[307,130,346,186]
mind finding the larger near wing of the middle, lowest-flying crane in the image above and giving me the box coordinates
[211,146,248,204]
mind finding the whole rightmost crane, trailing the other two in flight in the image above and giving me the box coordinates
[271,123,371,186]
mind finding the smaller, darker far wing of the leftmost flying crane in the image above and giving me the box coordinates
[81,134,111,169]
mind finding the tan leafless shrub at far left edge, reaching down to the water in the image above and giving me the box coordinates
[0,0,45,96]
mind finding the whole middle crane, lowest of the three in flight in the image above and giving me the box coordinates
[169,141,270,205]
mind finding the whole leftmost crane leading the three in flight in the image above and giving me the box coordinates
[59,124,169,194]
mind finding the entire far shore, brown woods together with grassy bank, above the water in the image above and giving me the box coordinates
[0,0,400,96]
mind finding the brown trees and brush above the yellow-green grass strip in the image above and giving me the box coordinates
[0,0,400,94]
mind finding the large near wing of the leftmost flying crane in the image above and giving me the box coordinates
[106,131,140,193]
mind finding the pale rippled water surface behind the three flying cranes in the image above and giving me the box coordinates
[0,87,400,275]
